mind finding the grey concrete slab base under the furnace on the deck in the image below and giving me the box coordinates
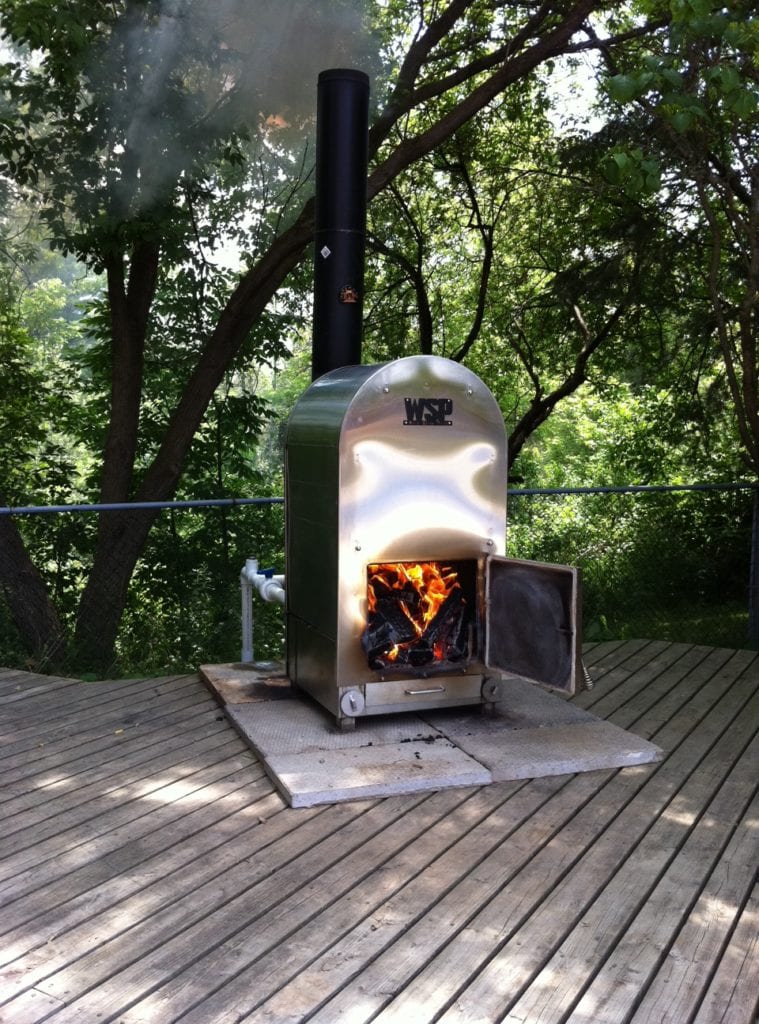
[201,665,663,807]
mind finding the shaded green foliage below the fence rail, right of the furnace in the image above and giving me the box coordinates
[508,492,752,647]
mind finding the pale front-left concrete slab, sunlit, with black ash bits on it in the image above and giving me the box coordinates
[266,738,492,807]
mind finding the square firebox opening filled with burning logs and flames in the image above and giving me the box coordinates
[362,560,477,674]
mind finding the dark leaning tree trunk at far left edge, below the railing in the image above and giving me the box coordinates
[0,507,66,670]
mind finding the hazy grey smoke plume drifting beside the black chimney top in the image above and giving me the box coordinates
[92,0,376,209]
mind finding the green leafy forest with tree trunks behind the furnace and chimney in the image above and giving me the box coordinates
[0,0,759,676]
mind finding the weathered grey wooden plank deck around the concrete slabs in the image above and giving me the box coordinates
[0,641,759,1024]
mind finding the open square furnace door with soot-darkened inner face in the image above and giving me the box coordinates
[484,555,582,694]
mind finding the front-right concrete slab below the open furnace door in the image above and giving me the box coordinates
[454,719,664,782]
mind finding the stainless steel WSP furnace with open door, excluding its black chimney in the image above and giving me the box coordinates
[286,355,581,727]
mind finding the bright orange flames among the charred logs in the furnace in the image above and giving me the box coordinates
[368,562,460,662]
